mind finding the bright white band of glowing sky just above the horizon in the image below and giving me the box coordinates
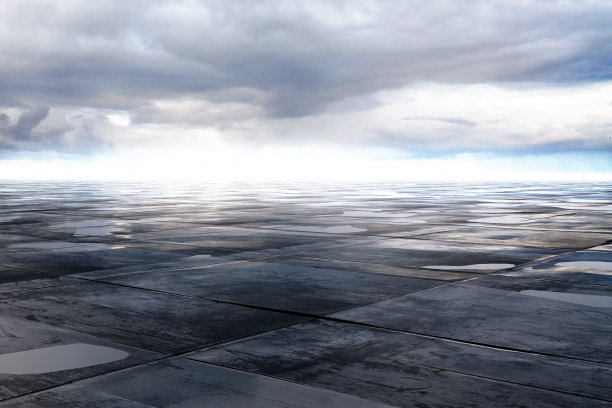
[0,145,612,182]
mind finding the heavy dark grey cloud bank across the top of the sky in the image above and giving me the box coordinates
[0,0,612,153]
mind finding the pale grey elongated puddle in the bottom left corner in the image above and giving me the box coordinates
[0,343,129,375]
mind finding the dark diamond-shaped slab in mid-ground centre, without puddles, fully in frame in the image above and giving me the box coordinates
[105,261,446,315]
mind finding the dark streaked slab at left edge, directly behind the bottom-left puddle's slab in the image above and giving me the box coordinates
[0,279,306,353]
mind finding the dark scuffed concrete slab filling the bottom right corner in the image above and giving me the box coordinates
[187,320,612,407]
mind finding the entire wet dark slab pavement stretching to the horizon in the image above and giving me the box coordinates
[0,182,612,408]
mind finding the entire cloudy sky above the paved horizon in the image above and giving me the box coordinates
[0,0,612,180]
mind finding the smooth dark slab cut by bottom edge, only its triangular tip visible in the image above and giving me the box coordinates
[0,358,390,408]
